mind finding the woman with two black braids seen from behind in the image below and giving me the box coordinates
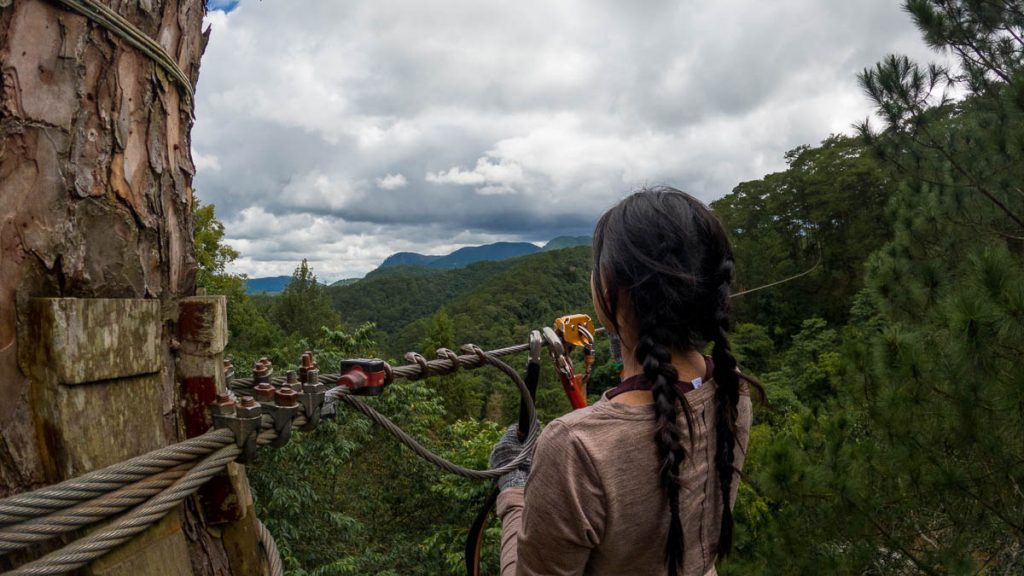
[492,188,751,576]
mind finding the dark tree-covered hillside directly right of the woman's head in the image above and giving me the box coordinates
[712,135,891,341]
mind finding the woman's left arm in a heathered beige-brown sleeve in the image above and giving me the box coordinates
[498,420,605,576]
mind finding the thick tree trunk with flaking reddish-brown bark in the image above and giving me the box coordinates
[0,0,237,574]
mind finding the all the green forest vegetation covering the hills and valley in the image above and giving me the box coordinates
[197,0,1024,575]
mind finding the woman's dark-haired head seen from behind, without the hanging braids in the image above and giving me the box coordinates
[594,188,732,348]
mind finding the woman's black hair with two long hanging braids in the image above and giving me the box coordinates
[594,188,739,576]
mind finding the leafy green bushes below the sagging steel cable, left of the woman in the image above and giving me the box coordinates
[249,375,512,575]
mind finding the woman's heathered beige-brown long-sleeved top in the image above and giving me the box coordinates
[498,380,752,576]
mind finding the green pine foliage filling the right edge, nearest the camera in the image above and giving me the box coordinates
[723,0,1024,574]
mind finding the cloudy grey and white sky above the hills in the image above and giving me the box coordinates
[193,0,934,280]
